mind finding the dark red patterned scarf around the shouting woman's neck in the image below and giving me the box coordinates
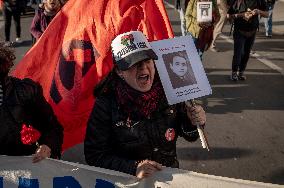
[116,79,165,117]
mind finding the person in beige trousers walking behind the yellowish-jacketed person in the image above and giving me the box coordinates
[210,0,228,52]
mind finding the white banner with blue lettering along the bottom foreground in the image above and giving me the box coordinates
[0,156,283,188]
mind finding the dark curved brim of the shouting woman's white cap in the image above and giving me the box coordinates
[116,49,158,71]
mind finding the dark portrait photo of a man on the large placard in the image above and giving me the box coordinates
[162,50,197,89]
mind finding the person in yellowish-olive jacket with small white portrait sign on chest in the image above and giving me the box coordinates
[185,0,220,59]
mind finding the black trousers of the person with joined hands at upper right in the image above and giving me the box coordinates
[232,31,255,72]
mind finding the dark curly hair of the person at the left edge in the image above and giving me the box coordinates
[0,45,16,73]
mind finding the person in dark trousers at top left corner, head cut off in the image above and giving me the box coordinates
[3,0,26,46]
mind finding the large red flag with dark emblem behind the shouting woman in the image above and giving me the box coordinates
[13,0,173,149]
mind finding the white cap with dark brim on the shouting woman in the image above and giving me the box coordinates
[111,31,158,70]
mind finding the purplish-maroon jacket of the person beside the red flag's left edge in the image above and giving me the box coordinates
[30,8,55,40]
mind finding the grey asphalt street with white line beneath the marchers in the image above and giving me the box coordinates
[0,0,284,185]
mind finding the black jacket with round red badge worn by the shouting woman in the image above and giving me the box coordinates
[84,76,198,175]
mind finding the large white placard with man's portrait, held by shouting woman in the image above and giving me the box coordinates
[151,36,212,105]
